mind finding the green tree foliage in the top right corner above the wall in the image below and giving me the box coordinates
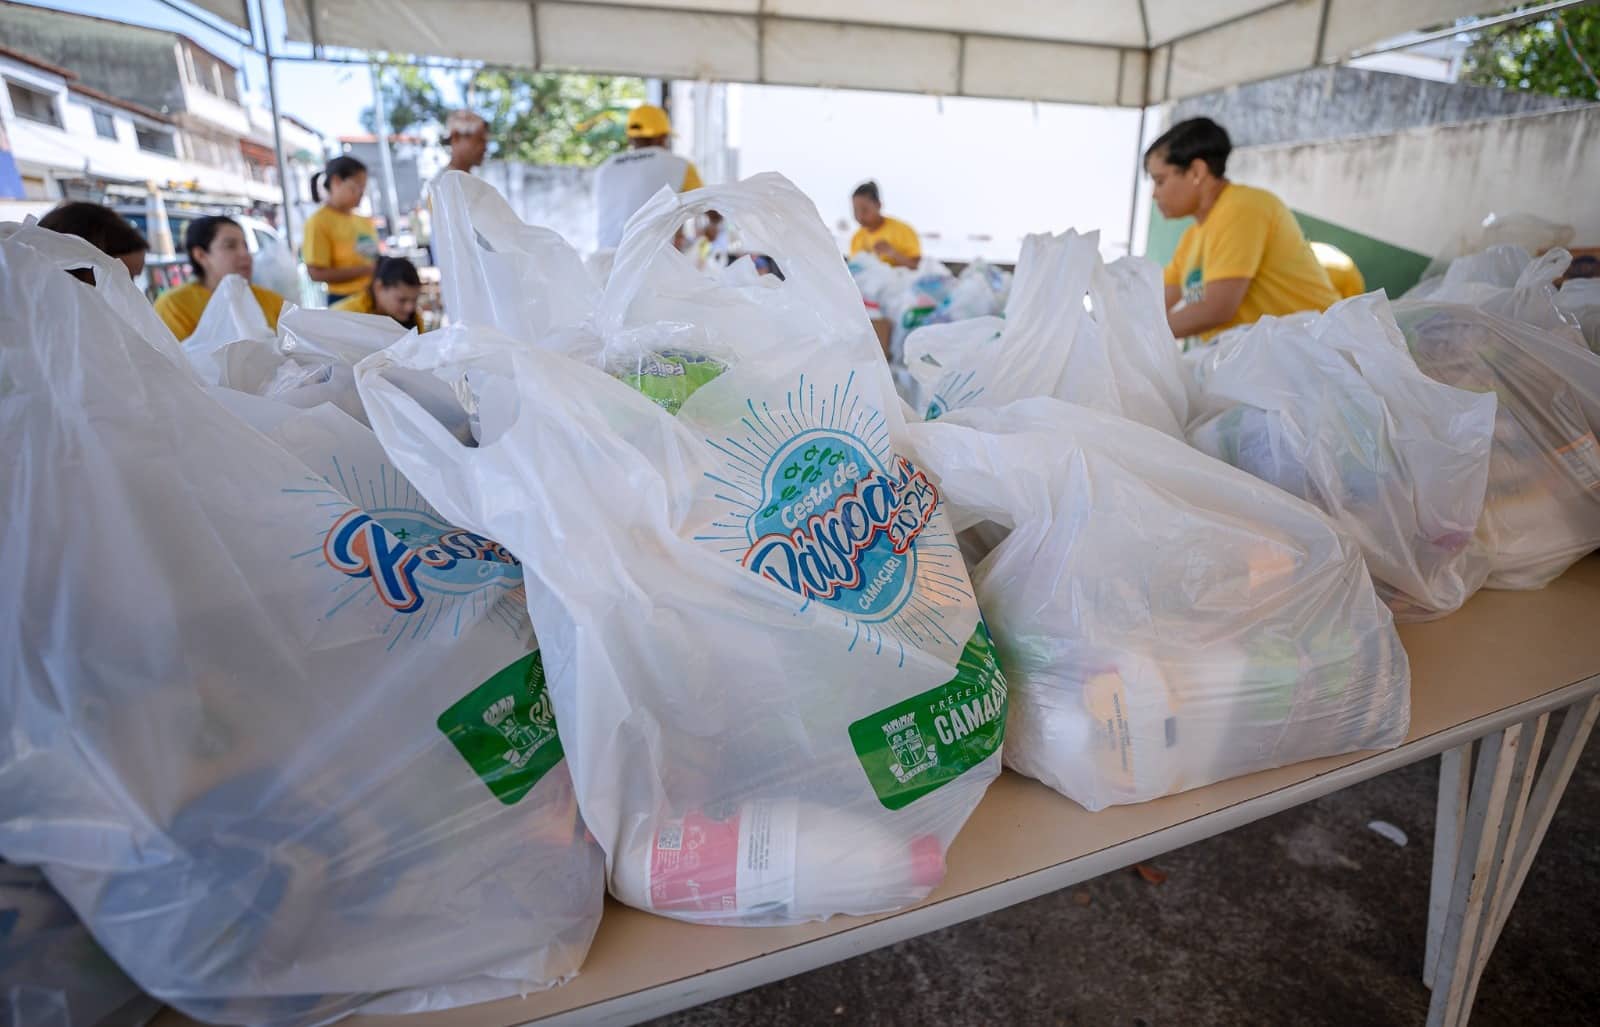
[1461,6,1600,99]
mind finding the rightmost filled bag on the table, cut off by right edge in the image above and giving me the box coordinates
[1395,301,1600,589]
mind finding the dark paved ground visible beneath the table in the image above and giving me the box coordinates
[643,725,1600,1027]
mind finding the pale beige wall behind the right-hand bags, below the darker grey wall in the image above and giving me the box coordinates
[1147,104,1600,294]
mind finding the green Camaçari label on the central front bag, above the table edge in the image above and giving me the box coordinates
[850,621,1006,809]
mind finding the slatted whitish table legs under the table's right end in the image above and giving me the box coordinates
[1422,696,1600,1027]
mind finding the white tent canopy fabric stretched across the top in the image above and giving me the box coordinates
[278,0,1504,107]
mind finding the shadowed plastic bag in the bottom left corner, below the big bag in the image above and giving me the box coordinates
[0,862,162,1027]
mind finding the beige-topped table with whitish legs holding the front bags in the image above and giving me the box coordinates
[157,557,1600,1027]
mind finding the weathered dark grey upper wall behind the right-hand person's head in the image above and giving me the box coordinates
[1168,66,1581,146]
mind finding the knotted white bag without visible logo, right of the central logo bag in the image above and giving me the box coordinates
[909,398,1410,809]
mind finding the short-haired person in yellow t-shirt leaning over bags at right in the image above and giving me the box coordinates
[1144,118,1339,339]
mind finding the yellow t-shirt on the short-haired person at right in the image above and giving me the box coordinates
[1163,182,1339,339]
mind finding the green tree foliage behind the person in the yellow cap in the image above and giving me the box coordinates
[362,58,645,165]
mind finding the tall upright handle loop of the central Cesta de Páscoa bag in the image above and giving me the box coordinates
[598,173,870,336]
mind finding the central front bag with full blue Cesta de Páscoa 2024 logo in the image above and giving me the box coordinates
[368,174,1006,925]
